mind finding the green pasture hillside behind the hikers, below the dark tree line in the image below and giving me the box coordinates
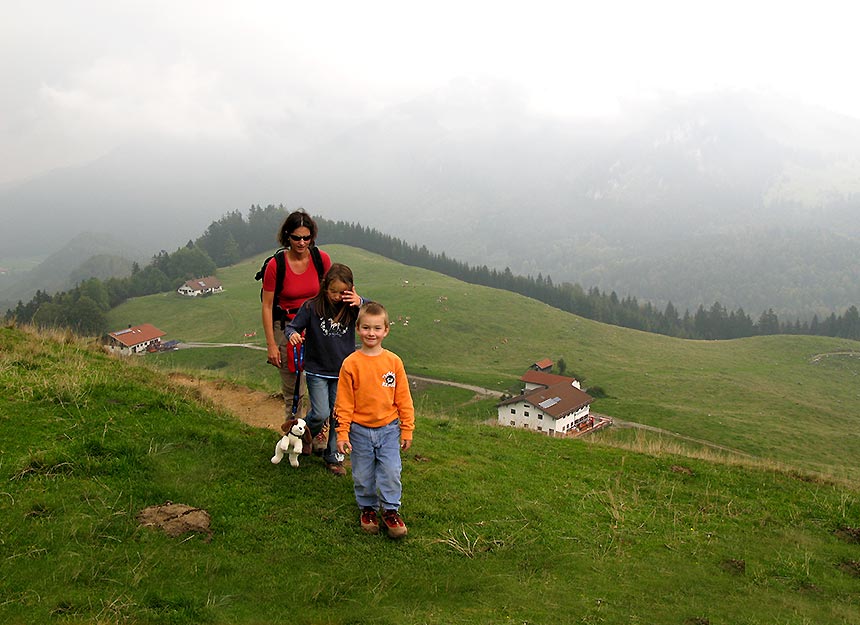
[110,245,860,479]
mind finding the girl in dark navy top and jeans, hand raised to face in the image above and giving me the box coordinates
[284,263,364,475]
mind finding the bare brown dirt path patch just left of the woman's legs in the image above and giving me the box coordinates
[170,373,285,432]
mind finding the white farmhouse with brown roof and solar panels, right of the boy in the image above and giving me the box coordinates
[497,369,594,436]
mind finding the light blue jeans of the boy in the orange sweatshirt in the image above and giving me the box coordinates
[349,419,403,510]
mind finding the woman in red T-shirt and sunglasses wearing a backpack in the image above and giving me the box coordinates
[263,210,331,428]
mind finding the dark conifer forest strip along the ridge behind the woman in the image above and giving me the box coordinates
[6,205,860,340]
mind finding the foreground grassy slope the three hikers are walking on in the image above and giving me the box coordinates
[5,324,860,625]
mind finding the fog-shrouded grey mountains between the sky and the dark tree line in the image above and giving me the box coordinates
[6,81,860,316]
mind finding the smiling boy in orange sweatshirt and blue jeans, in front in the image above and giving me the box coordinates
[335,302,415,538]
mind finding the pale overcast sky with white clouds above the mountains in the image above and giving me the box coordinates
[0,0,860,183]
